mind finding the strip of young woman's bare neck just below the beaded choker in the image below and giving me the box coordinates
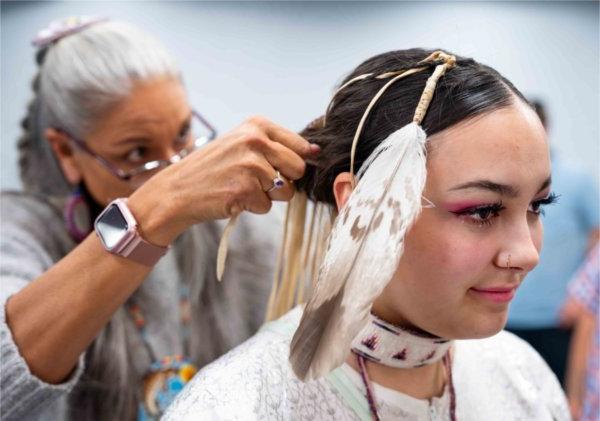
[346,352,447,399]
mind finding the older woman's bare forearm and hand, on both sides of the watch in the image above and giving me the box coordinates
[6,117,318,383]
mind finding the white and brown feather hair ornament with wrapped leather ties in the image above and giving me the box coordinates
[289,51,456,380]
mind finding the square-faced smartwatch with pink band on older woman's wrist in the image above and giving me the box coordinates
[94,198,169,266]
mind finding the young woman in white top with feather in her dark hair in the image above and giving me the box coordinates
[166,49,569,421]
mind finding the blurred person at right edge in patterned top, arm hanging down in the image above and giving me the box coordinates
[563,245,600,421]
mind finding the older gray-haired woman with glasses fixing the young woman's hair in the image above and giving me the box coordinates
[0,19,319,420]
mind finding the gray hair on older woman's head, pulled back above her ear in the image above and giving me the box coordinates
[18,22,181,196]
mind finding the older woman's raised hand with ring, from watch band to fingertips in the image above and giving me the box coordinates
[129,117,319,245]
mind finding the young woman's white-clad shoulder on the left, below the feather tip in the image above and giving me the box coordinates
[164,309,300,420]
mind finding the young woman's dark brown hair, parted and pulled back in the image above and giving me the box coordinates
[296,48,528,205]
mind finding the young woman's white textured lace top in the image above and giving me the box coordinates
[164,307,570,421]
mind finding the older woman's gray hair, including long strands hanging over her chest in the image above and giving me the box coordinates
[19,22,269,420]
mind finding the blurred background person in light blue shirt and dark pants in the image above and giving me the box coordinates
[507,101,600,386]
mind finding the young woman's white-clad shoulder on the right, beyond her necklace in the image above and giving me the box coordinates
[453,331,570,420]
